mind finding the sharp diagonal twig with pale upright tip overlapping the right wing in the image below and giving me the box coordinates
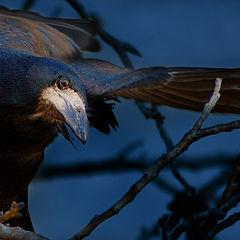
[71,78,222,240]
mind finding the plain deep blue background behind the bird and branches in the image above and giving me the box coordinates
[0,0,240,240]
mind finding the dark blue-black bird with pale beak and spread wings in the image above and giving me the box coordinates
[0,7,240,230]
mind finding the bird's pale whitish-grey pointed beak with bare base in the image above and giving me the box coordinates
[42,86,88,144]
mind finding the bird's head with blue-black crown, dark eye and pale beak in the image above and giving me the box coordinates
[26,58,88,143]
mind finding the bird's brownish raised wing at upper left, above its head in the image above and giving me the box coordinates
[0,7,99,61]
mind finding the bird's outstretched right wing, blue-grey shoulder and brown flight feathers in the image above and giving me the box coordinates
[69,60,240,113]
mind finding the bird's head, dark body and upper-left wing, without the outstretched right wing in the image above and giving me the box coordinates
[0,9,98,229]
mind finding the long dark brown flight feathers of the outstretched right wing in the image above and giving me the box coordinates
[112,68,240,113]
